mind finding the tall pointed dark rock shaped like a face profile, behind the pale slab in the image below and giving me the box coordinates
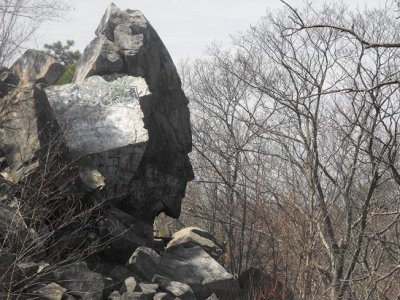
[72,4,193,223]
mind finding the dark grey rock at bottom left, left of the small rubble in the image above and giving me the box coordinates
[54,262,104,300]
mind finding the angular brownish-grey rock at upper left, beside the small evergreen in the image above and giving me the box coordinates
[11,50,65,87]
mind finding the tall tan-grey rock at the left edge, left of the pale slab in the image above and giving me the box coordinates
[0,86,62,182]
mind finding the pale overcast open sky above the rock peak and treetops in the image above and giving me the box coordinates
[31,0,391,62]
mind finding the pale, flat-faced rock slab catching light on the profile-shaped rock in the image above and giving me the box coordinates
[46,74,150,155]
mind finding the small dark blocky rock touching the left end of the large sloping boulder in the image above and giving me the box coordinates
[127,246,161,281]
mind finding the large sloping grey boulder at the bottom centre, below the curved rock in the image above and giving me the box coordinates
[157,246,239,299]
